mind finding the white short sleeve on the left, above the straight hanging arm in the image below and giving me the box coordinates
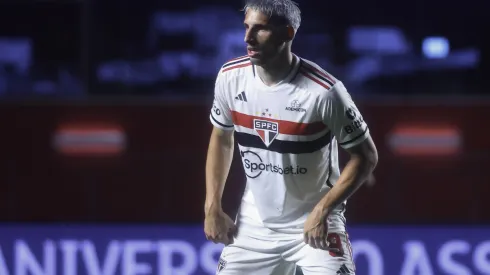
[209,73,234,130]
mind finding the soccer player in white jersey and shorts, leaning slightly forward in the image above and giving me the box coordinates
[204,0,377,275]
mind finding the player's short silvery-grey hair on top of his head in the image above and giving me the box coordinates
[243,0,301,31]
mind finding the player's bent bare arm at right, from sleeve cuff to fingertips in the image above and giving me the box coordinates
[304,137,378,249]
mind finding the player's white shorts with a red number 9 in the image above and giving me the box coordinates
[216,221,355,275]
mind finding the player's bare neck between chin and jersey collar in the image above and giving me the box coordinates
[257,51,293,86]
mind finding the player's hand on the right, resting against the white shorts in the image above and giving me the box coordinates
[303,207,329,250]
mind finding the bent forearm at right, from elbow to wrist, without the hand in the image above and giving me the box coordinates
[316,156,377,216]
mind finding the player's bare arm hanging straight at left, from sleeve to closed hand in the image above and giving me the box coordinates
[204,127,236,244]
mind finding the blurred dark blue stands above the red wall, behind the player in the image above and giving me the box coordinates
[0,0,486,99]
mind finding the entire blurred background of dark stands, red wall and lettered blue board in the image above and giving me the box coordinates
[0,0,490,275]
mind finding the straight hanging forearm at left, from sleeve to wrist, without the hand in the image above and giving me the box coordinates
[204,132,234,216]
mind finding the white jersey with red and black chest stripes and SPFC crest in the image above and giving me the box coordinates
[210,55,369,231]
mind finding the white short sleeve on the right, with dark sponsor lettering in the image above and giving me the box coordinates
[319,81,369,149]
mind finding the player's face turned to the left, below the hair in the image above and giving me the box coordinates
[243,9,286,65]
